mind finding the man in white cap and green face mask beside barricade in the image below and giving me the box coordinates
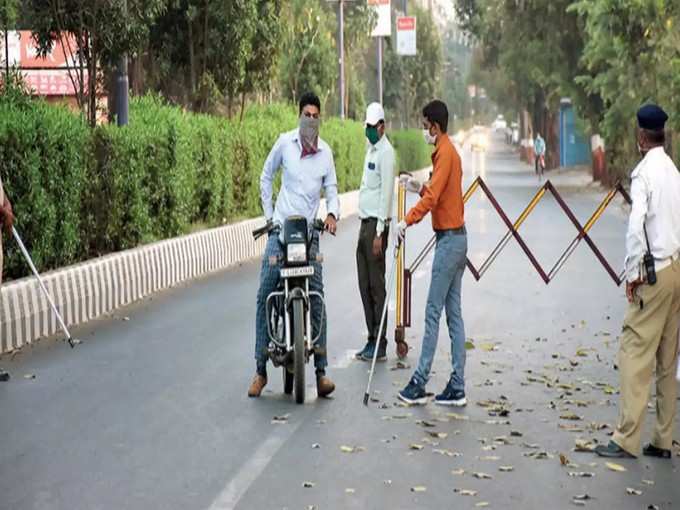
[357,103,395,361]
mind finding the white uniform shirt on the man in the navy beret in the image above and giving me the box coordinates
[624,147,680,282]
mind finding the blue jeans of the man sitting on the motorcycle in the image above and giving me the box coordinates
[255,231,328,373]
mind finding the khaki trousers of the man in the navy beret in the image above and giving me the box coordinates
[612,260,680,455]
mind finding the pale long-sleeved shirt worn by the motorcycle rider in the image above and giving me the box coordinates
[260,129,340,228]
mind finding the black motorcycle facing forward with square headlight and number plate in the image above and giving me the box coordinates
[253,216,326,404]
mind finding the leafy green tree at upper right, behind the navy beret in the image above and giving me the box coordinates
[572,0,680,177]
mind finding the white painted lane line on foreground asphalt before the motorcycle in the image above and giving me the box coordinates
[209,420,302,510]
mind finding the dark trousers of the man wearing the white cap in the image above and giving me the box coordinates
[357,218,389,343]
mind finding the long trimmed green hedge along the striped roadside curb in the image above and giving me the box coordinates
[0,96,430,278]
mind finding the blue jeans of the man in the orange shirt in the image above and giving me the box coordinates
[413,231,467,390]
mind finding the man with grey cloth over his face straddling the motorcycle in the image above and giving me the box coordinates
[248,92,340,397]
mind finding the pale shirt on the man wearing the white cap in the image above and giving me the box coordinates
[359,135,395,235]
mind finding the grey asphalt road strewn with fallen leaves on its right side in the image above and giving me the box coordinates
[0,133,680,510]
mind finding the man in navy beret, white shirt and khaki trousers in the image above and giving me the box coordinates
[595,105,680,459]
